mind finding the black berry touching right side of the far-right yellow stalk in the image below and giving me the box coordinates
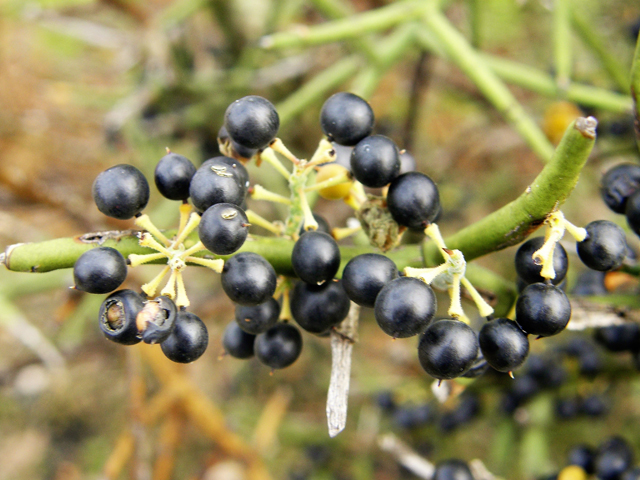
[576,220,627,272]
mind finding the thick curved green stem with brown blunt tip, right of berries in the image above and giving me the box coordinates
[424,117,596,266]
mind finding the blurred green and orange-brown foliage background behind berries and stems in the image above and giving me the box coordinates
[0,0,640,480]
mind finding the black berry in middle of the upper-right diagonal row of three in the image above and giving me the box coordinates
[351,135,400,188]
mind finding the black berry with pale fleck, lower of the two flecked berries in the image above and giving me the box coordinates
[198,203,249,255]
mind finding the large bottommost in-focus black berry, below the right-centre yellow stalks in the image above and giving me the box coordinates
[418,320,478,380]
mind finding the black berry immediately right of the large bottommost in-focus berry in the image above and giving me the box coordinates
[478,318,529,372]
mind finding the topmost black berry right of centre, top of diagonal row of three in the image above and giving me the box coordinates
[320,92,375,146]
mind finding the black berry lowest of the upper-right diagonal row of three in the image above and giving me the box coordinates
[387,172,440,229]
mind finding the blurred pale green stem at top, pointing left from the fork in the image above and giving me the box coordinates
[260,0,428,48]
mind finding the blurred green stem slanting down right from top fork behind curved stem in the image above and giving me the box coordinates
[424,2,553,162]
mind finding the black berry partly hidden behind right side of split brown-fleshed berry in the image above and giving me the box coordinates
[160,311,209,363]
